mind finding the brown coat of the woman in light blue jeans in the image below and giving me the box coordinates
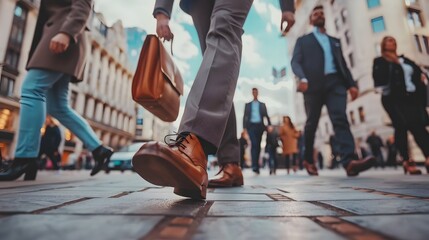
[27,0,92,81]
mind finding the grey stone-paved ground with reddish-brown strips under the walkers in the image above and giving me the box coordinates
[0,168,429,240]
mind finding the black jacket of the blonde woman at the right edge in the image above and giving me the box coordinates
[372,56,427,106]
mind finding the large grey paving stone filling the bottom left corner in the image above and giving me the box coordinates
[0,215,162,240]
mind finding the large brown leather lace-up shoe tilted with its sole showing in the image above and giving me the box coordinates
[133,133,208,199]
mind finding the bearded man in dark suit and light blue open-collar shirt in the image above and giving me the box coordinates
[292,6,375,176]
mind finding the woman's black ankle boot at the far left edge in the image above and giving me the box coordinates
[0,158,37,181]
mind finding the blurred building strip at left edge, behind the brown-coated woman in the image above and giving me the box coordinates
[0,0,40,157]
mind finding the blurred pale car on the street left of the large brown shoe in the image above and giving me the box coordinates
[105,142,145,173]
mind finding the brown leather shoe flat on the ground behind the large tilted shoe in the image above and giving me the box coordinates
[209,163,243,188]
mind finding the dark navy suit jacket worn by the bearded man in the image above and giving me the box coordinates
[291,33,356,93]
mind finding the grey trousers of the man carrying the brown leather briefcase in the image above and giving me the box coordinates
[179,0,252,164]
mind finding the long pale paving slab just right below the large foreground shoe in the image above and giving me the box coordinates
[208,201,337,217]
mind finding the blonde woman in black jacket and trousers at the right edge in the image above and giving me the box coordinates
[373,36,429,174]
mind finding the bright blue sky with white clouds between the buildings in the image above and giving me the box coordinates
[95,0,294,132]
